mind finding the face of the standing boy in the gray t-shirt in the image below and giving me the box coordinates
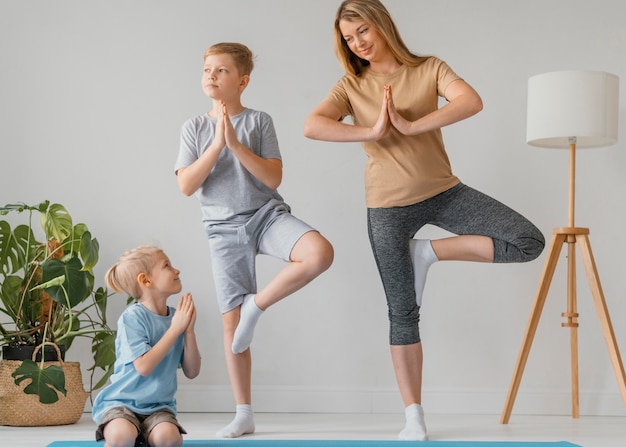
[202,53,250,101]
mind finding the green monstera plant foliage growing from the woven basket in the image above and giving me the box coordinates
[0,200,115,403]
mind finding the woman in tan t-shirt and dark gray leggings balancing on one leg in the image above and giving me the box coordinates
[304,0,545,440]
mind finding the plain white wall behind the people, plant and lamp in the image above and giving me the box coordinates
[0,0,626,415]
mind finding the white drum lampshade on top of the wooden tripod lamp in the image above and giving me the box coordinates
[526,71,619,148]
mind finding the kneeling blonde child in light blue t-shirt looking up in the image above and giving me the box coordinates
[92,246,200,447]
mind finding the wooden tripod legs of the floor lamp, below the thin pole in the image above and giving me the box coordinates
[500,227,626,424]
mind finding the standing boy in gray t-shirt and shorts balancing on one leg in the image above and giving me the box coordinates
[175,43,333,438]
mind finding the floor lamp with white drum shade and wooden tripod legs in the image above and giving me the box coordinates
[500,71,626,424]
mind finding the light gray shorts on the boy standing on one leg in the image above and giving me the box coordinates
[206,200,315,314]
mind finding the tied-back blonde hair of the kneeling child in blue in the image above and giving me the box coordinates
[105,245,163,299]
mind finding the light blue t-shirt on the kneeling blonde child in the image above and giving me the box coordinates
[92,303,184,423]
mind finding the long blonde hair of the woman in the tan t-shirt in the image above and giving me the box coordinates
[335,0,426,76]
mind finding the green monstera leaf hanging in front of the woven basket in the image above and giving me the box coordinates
[11,360,67,404]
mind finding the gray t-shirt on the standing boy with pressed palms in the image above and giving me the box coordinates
[175,109,283,225]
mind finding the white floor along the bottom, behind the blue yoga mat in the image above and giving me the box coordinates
[0,413,626,447]
